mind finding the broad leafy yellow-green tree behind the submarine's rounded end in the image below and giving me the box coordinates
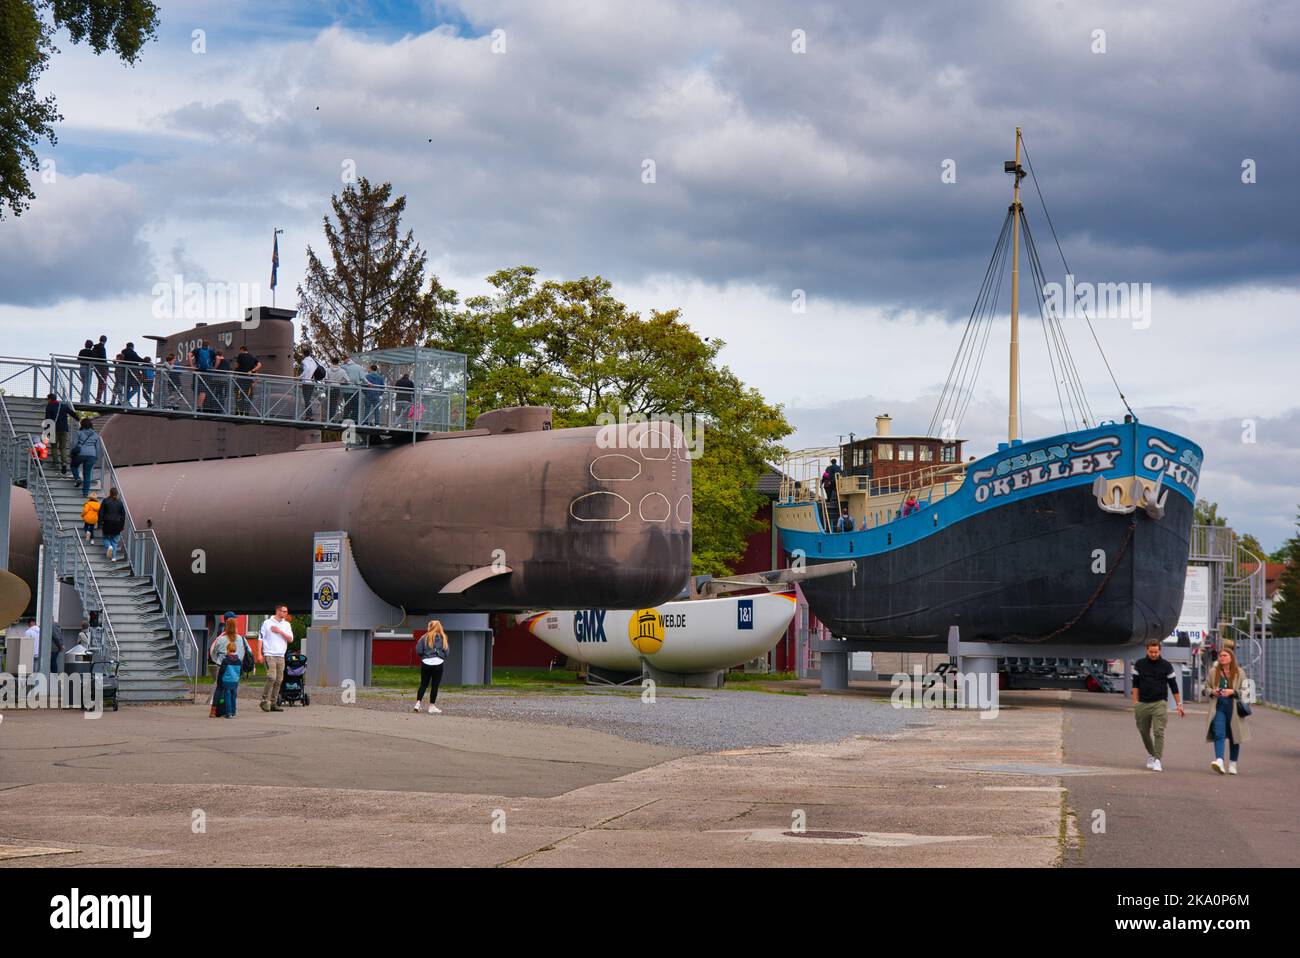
[428,266,790,575]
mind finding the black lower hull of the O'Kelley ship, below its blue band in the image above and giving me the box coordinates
[802,487,1192,649]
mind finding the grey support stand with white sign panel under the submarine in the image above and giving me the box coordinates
[303,532,406,686]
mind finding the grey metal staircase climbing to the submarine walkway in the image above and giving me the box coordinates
[0,396,202,702]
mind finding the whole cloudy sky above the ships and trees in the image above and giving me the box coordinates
[0,0,1300,549]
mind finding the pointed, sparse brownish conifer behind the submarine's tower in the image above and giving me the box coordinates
[298,177,441,356]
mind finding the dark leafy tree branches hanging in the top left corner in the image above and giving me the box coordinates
[0,0,157,220]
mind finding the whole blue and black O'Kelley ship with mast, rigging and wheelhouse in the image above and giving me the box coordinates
[774,130,1203,654]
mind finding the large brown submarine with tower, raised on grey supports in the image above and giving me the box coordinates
[10,308,692,614]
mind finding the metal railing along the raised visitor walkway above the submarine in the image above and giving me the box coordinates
[0,356,465,438]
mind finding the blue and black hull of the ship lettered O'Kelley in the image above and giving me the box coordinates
[777,424,1201,650]
